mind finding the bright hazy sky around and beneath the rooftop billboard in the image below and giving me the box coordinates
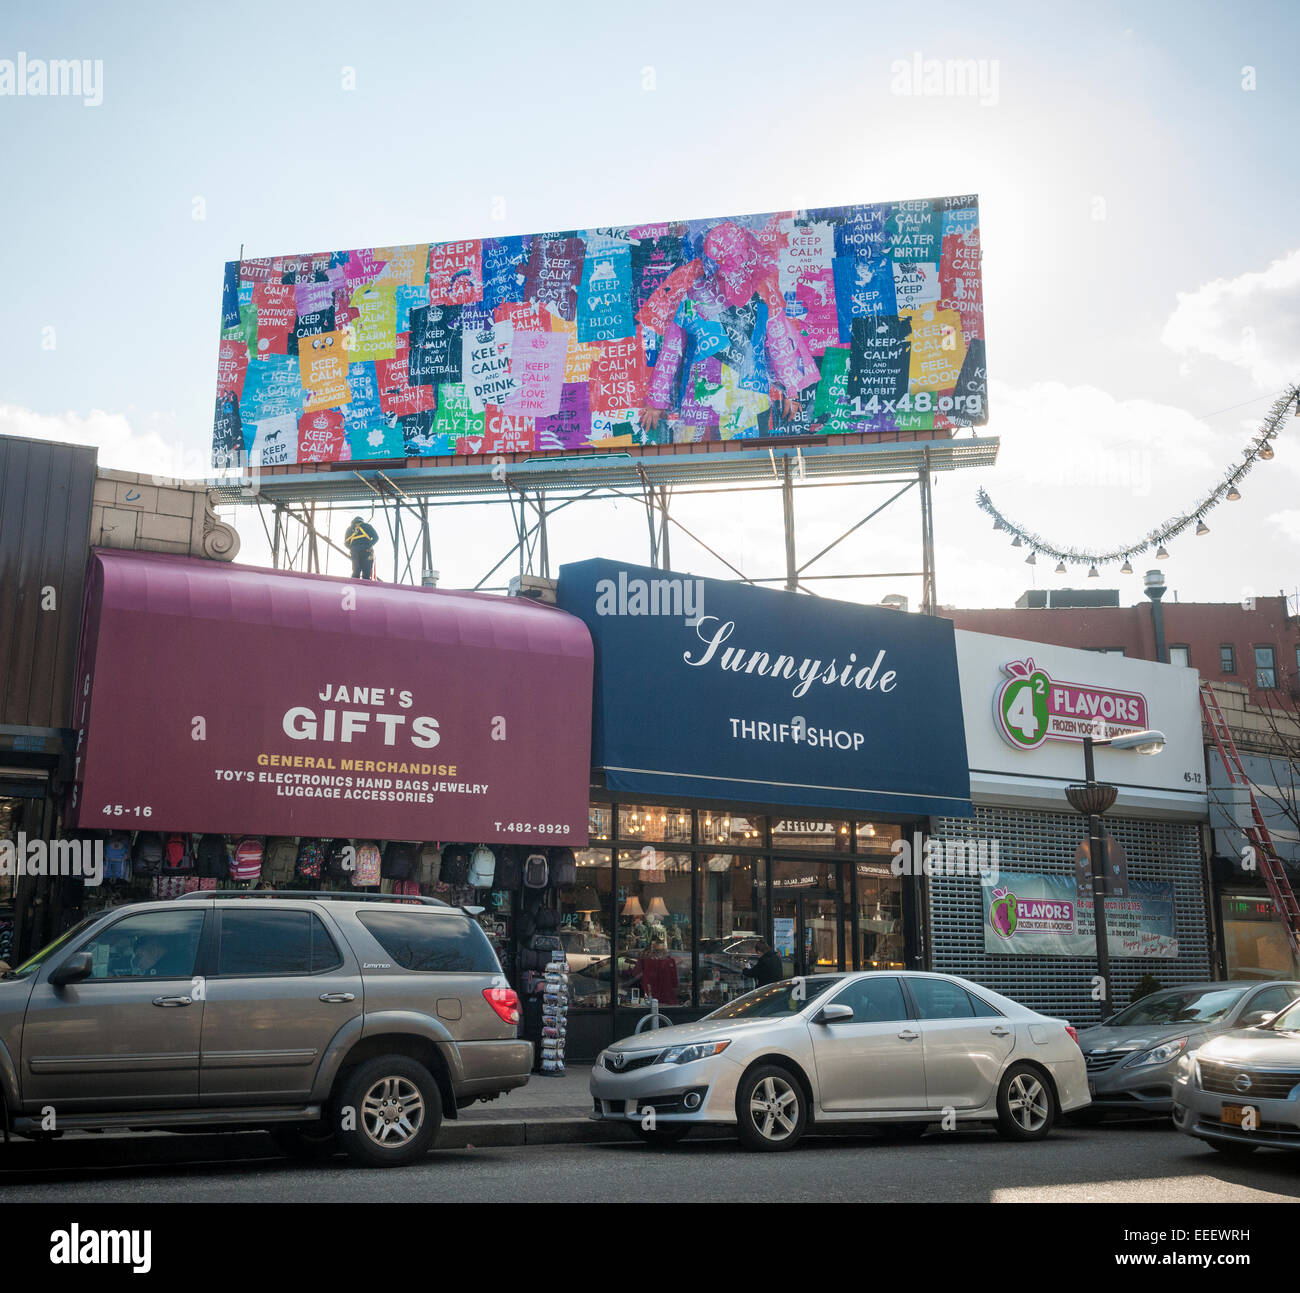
[0,0,1300,607]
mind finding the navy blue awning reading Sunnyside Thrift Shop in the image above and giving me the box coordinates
[558,560,971,816]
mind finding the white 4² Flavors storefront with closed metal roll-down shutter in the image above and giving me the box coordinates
[926,630,1212,1024]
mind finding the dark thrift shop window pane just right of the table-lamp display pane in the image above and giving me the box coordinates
[698,852,766,1007]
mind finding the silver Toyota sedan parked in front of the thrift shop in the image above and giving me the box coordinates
[592,971,1088,1150]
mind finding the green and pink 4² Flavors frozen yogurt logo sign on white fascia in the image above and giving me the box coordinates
[993,658,1147,750]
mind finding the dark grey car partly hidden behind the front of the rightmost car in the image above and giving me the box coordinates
[1076,980,1300,1121]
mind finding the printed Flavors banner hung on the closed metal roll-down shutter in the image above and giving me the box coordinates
[980,871,1178,958]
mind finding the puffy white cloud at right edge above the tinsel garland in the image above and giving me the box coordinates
[1161,250,1300,387]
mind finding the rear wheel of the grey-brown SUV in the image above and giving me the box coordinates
[335,1055,442,1167]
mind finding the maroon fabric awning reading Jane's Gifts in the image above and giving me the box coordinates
[70,548,592,846]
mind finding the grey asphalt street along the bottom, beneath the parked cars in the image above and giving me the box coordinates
[0,1120,1300,1203]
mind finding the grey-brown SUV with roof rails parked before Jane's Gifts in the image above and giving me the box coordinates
[0,890,533,1167]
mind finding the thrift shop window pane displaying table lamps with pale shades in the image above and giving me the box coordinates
[615,845,693,1007]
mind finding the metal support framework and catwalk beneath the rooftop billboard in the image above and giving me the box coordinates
[218,437,998,615]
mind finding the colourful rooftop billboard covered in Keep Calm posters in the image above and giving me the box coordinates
[212,195,988,467]
